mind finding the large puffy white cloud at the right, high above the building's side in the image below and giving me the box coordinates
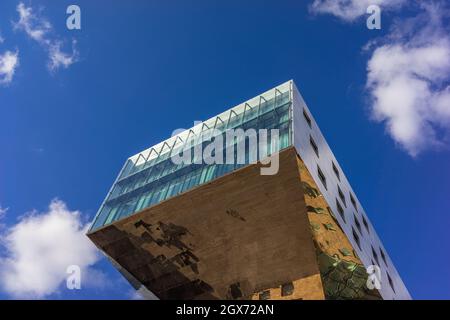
[367,3,450,156]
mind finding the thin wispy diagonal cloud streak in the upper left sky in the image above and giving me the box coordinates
[14,2,78,71]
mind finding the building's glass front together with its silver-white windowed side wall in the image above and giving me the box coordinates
[90,81,410,299]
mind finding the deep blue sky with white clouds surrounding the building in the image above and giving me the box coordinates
[0,0,450,299]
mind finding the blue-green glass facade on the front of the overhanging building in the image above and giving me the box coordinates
[90,82,293,231]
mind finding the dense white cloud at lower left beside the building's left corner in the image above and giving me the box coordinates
[0,200,100,298]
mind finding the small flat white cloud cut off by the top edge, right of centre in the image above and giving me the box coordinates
[309,0,406,22]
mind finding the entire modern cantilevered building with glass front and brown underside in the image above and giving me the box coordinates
[88,81,410,299]
